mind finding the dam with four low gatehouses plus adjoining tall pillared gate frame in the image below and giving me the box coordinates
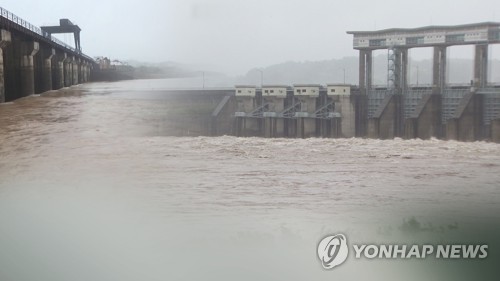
[210,22,500,142]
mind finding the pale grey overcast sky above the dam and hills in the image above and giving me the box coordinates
[0,0,500,74]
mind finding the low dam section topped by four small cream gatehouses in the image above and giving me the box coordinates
[230,84,357,138]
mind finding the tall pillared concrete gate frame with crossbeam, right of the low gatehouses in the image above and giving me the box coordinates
[347,22,500,141]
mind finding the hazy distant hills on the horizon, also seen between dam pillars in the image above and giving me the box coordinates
[122,55,500,87]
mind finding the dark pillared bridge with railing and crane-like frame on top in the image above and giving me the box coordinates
[0,7,95,102]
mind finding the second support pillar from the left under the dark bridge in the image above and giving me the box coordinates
[21,41,40,97]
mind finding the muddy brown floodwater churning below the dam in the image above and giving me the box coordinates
[0,77,500,281]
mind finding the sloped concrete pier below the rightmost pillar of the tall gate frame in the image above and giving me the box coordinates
[446,93,483,141]
